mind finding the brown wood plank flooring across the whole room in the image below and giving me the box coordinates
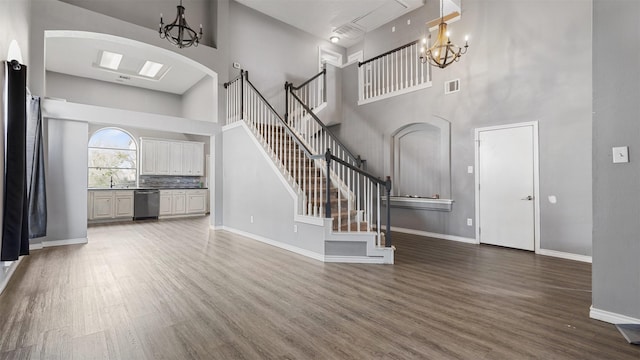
[0,217,640,360]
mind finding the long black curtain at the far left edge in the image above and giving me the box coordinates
[0,61,29,261]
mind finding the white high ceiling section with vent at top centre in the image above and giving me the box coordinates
[237,0,425,47]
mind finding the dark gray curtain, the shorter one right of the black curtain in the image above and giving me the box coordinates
[27,95,47,239]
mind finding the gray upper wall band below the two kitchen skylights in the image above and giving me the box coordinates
[46,71,182,121]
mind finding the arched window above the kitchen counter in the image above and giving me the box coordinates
[89,128,138,188]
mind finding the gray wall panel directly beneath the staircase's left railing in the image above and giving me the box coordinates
[222,127,324,255]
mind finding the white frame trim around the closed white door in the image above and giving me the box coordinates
[474,121,540,254]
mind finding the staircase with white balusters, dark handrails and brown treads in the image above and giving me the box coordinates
[225,71,394,263]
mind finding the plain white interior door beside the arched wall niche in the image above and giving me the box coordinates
[476,123,537,250]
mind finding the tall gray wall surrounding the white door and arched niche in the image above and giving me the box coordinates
[339,0,592,255]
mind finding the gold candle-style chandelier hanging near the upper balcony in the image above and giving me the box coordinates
[420,1,469,69]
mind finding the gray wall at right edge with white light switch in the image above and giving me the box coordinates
[592,0,640,319]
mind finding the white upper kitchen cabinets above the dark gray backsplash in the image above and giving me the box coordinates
[140,138,204,176]
